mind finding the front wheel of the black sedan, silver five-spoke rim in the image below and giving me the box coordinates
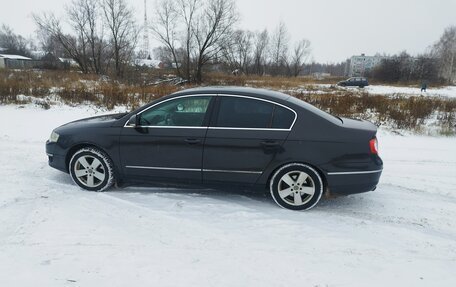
[68,147,115,191]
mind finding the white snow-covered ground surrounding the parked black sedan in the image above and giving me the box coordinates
[0,105,456,287]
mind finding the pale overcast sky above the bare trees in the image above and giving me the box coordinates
[0,0,456,62]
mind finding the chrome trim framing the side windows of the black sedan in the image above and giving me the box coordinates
[124,94,298,132]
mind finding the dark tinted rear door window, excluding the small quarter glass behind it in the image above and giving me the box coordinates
[216,97,274,128]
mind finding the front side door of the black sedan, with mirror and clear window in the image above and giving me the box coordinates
[120,95,214,183]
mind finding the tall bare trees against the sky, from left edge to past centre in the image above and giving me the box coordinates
[0,0,310,82]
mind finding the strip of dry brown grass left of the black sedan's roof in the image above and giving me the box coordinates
[0,70,183,109]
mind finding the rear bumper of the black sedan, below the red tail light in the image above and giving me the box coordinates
[326,170,382,195]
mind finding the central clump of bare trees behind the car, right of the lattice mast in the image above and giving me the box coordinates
[151,0,310,82]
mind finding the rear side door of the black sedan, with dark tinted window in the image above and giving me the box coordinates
[203,95,296,184]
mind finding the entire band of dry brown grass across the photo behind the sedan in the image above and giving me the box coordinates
[0,70,456,134]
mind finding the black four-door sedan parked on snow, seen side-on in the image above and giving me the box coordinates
[46,87,383,210]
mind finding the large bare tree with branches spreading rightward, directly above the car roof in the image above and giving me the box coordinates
[193,0,238,82]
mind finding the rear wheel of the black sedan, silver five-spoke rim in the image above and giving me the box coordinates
[269,163,323,210]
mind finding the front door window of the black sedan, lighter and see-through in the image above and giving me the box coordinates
[140,96,211,127]
